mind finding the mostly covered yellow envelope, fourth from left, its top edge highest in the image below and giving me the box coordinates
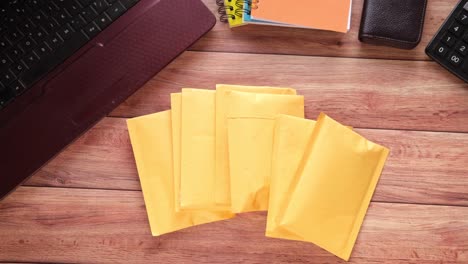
[215,84,296,206]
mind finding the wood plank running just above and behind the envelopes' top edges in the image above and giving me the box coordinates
[111,52,468,132]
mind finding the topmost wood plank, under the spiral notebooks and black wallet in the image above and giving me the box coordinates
[195,0,458,60]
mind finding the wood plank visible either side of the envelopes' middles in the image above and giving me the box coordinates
[27,118,468,206]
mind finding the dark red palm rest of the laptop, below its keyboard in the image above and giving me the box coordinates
[0,0,216,199]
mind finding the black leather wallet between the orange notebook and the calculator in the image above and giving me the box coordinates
[359,0,427,49]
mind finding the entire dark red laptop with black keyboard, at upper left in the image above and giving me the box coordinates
[0,0,216,200]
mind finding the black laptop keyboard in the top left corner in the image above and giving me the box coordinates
[0,0,139,110]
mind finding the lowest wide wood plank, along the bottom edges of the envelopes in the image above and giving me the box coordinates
[0,187,468,264]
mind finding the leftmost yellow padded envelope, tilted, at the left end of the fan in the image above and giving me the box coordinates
[127,111,232,236]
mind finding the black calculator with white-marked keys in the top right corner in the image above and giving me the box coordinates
[426,0,468,82]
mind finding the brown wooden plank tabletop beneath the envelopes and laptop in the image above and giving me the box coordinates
[0,0,468,264]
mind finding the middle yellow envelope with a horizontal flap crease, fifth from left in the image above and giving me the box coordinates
[227,91,304,213]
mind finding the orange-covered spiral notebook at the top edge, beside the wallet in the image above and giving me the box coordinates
[251,0,352,33]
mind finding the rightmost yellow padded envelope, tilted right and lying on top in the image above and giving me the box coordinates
[280,114,389,260]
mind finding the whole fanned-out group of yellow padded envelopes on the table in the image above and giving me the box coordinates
[127,85,389,260]
